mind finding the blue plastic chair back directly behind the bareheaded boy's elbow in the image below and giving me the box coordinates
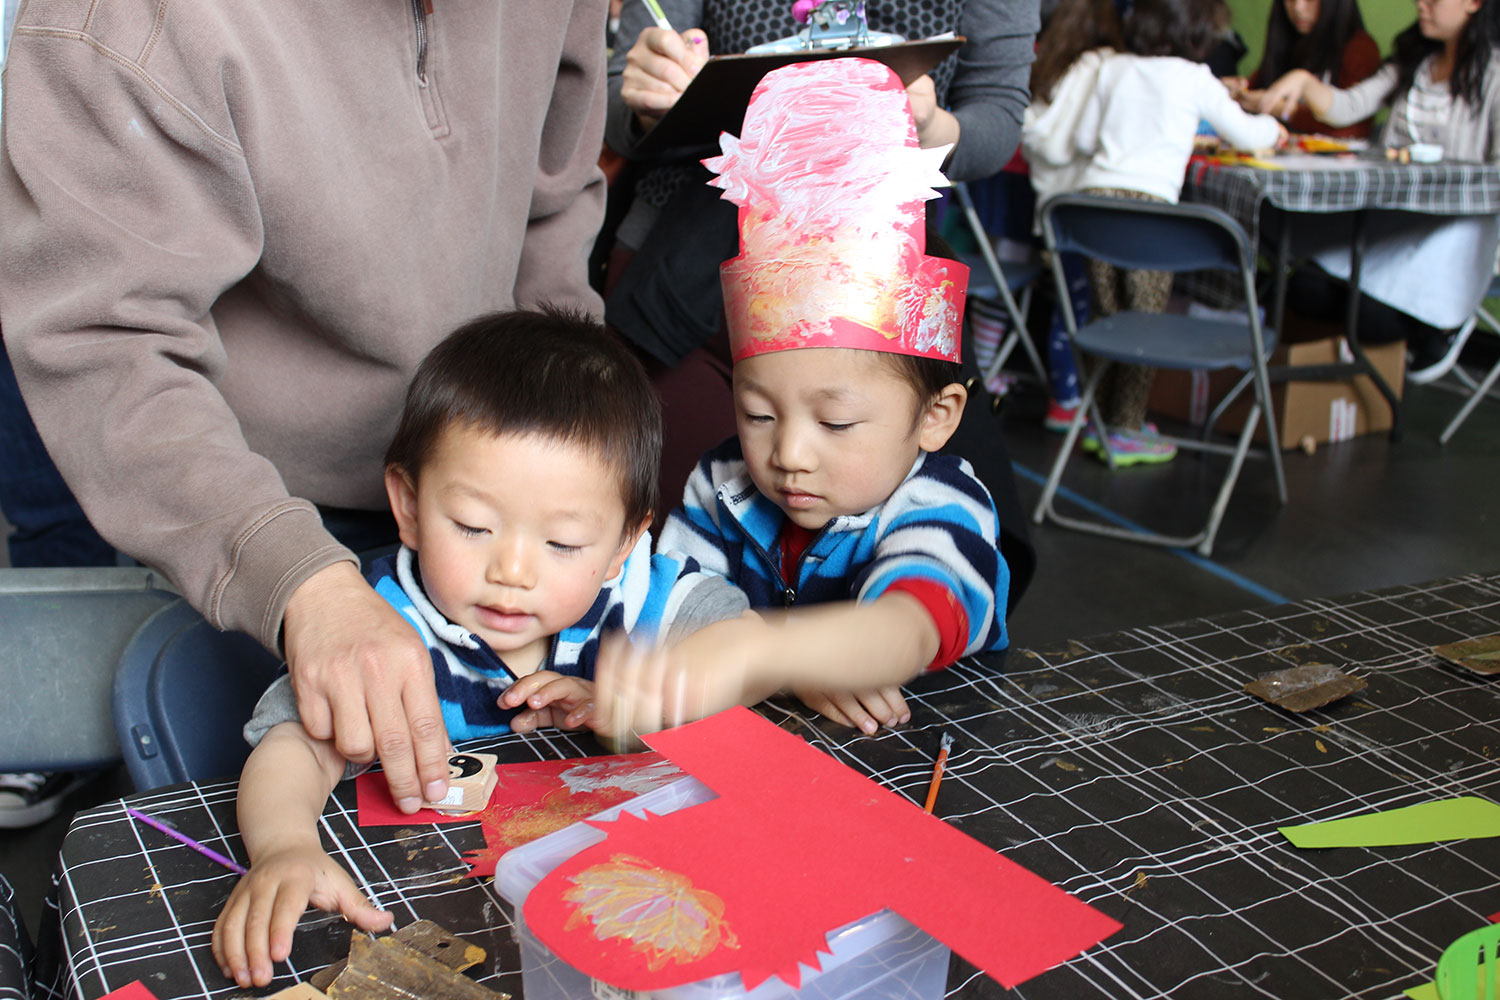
[113,600,281,792]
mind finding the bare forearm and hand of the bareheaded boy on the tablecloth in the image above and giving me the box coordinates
[213,723,392,987]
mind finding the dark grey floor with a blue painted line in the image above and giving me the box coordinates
[0,358,1500,947]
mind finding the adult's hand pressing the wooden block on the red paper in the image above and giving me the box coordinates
[282,562,449,813]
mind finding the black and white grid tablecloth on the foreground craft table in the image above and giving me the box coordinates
[41,574,1500,1000]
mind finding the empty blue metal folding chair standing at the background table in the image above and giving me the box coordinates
[1032,195,1287,556]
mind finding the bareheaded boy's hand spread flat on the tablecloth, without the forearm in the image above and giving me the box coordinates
[213,844,392,987]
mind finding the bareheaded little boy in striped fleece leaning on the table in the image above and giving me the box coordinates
[213,312,747,987]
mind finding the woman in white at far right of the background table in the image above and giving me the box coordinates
[1260,0,1500,382]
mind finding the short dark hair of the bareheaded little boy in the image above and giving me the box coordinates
[386,307,662,531]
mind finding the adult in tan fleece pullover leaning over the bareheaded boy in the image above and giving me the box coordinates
[0,0,606,808]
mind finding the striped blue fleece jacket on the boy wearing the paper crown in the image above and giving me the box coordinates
[657,438,1010,655]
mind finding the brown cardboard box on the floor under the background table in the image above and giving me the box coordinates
[1148,337,1406,448]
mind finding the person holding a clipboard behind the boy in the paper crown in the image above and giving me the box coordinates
[605,0,1040,617]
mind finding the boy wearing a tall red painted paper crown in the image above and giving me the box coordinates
[596,58,1010,735]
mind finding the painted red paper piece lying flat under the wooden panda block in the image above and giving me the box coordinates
[354,753,683,877]
